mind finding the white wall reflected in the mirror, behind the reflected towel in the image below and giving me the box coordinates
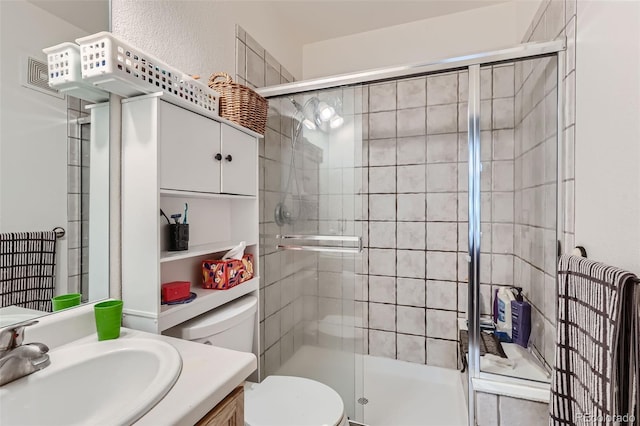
[0,0,86,290]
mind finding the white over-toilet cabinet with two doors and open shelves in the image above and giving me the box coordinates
[122,94,261,362]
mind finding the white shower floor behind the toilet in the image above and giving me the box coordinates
[277,345,467,426]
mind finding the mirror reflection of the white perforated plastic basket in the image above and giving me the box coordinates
[42,43,109,102]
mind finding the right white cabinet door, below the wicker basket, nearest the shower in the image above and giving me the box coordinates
[222,125,258,195]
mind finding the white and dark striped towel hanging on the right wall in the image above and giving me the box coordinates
[549,256,640,426]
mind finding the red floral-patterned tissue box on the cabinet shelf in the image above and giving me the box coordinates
[202,253,253,290]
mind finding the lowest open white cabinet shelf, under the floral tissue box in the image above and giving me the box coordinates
[158,277,260,331]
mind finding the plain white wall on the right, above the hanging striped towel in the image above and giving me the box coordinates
[575,0,640,273]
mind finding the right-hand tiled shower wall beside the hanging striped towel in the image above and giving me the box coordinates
[514,0,576,367]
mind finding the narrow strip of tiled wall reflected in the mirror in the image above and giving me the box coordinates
[66,96,90,300]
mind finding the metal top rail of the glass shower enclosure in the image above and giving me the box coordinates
[256,39,565,98]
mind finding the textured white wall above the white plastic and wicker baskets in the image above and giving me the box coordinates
[112,0,302,79]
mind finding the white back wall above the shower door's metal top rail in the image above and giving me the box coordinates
[302,1,536,79]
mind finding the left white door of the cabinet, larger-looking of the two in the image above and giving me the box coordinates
[158,102,221,192]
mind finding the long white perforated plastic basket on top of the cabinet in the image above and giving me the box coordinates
[76,31,220,116]
